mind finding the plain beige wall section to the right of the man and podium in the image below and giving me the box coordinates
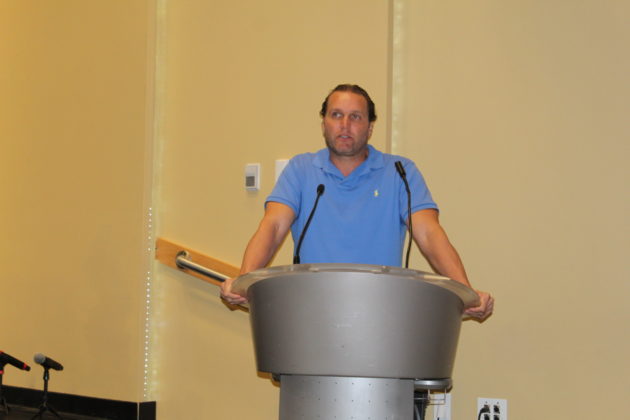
[392,0,630,420]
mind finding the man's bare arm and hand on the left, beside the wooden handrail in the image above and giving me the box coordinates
[221,201,295,305]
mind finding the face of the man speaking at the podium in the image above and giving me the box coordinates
[322,91,374,157]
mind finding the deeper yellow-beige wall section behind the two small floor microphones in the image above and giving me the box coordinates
[0,1,152,401]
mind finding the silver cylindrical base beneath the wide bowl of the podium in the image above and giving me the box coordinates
[280,375,414,420]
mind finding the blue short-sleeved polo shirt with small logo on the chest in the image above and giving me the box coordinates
[265,145,437,266]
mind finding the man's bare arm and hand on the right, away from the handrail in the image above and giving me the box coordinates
[411,209,494,319]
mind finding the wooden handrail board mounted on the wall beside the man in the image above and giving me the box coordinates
[155,238,240,286]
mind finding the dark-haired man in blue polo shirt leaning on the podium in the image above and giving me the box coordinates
[221,85,494,319]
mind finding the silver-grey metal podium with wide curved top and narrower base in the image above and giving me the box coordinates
[233,264,478,420]
